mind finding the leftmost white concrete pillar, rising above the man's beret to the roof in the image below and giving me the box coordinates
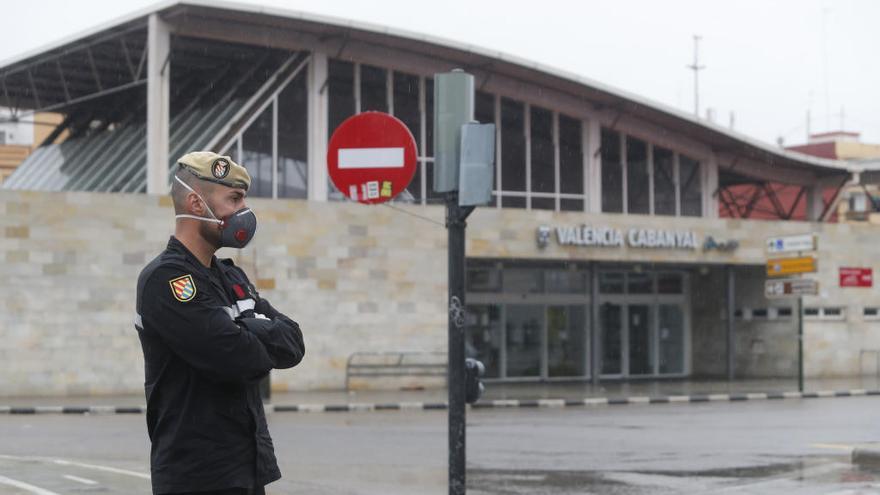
[147,14,171,194]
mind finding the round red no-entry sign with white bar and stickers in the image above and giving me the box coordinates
[327,112,416,204]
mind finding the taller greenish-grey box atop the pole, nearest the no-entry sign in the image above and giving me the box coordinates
[434,69,474,192]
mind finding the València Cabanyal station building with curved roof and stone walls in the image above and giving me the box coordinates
[0,1,880,394]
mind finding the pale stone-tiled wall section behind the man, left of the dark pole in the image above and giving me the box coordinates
[0,191,446,396]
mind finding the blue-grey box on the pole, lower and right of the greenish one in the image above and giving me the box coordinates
[458,122,495,206]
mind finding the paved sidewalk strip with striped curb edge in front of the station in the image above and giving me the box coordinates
[0,377,880,413]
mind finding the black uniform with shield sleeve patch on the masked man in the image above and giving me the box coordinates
[135,237,305,494]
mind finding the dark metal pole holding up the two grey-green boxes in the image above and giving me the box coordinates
[446,191,474,495]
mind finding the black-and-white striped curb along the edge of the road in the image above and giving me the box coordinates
[0,389,880,416]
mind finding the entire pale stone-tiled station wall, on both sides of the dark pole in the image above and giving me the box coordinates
[0,190,880,396]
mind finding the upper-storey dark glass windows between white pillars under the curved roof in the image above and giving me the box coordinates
[224,58,705,216]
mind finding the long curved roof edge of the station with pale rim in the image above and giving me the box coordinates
[0,0,858,177]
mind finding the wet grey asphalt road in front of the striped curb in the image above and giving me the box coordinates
[0,397,880,495]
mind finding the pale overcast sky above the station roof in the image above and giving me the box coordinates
[0,0,880,144]
